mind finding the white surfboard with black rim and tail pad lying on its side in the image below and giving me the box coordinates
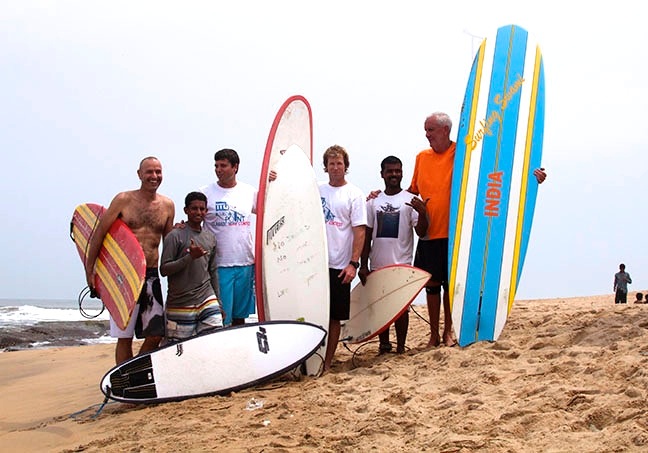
[101,321,326,403]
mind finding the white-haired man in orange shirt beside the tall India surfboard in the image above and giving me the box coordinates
[369,112,547,347]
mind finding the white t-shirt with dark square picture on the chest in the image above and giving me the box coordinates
[367,190,418,270]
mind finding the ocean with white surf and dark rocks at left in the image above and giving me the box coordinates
[0,298,115,352]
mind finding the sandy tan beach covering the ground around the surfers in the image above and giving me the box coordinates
[0,293,648,452]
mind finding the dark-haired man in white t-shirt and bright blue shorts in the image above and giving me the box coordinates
[200,148,257,326]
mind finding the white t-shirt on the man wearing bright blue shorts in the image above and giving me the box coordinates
[200,181,257,267]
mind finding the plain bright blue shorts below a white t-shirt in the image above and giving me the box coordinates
[218,264,256,326]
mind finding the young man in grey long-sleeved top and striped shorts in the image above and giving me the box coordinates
[160,192,223,342]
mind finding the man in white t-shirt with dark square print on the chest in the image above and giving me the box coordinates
[358,156,428,354]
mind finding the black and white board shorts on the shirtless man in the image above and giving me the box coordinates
[110,267,165,338]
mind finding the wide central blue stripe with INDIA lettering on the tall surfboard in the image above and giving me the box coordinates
[462,26,527,340]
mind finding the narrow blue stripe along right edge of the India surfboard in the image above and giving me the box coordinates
[517,59,545,284]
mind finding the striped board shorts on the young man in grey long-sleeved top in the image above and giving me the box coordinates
[166,295,223,342]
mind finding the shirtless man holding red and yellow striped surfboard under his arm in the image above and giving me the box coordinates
[85,157,175,364]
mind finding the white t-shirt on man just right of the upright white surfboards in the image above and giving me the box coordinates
[319,181,367,269]
